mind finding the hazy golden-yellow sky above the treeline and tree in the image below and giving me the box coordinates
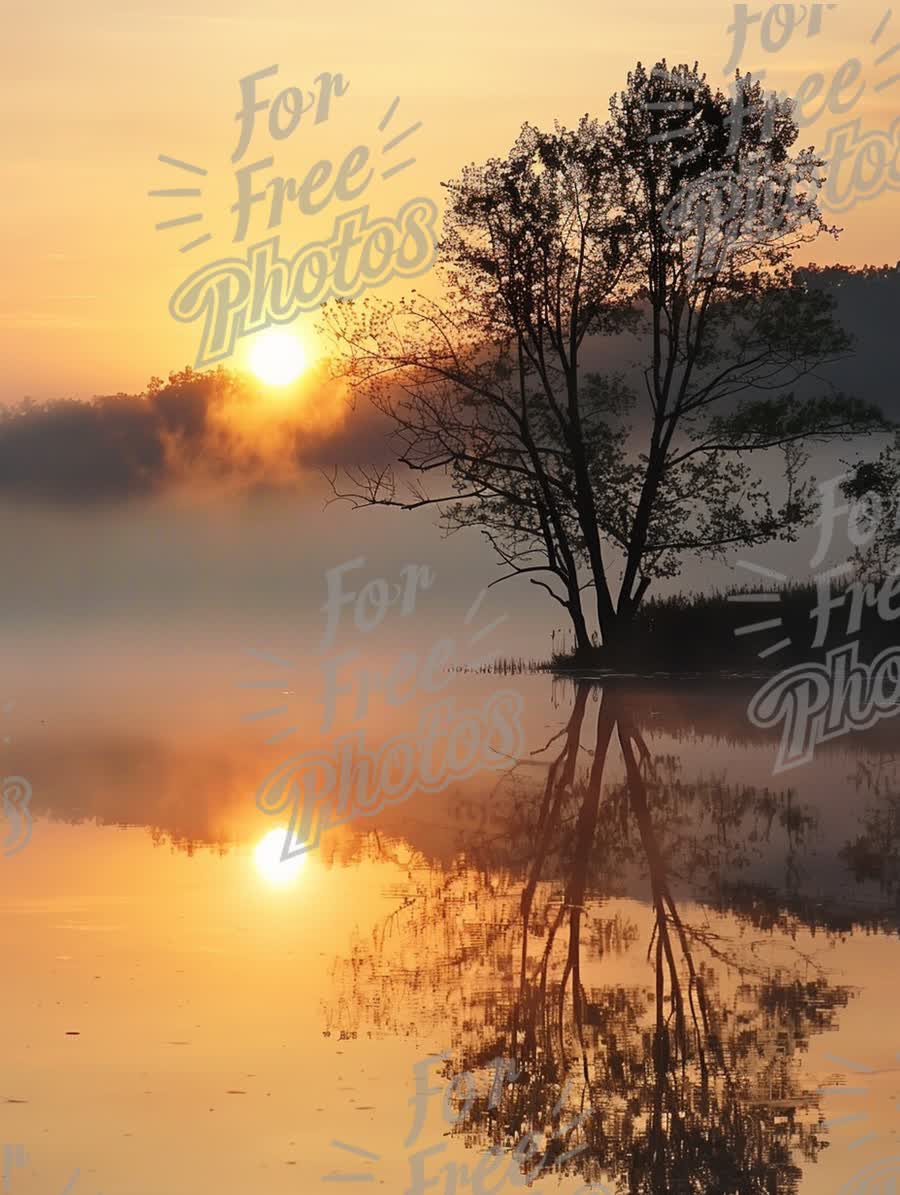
[0,0,900,400]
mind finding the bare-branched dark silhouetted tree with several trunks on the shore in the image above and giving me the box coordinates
[325,62,880,656]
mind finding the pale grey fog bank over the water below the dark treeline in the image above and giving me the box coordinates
[0,441,875,656]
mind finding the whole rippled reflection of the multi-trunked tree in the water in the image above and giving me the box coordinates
[332,686,847,1195]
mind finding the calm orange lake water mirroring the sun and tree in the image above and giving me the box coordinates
[0,675,900,1195]
